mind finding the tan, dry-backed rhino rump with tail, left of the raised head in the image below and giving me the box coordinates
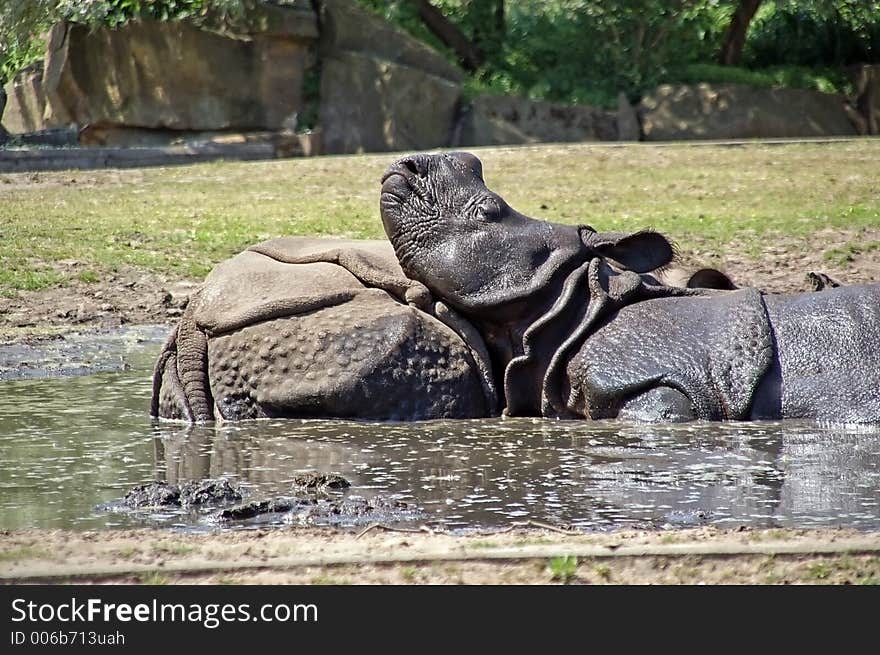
[151,238,495,422]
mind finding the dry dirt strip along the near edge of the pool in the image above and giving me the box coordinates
[0,527,880,585]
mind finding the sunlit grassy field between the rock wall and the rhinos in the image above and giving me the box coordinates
[0,139,880,295]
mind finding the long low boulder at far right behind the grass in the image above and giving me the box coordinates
[639,84,856,141]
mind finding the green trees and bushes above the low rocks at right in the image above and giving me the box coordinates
[359,0,880,107]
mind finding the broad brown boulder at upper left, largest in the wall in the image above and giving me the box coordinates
[44,8,316,130]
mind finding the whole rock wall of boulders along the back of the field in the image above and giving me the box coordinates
[0,0,880,154]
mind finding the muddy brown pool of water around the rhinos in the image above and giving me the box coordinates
[0,339,880,530]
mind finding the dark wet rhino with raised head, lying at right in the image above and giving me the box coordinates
[381,153,880,423]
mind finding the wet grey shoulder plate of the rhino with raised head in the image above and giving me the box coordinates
[567,289,772,419]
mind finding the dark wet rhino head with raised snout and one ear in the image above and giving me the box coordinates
[380,152,673,320]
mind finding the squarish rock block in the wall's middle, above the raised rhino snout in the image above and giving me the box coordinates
[320,52,461,154]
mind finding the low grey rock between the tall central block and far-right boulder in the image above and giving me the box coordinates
[455,95,618,146]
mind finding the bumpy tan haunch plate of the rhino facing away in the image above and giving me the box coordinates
[208,289,488,420]
